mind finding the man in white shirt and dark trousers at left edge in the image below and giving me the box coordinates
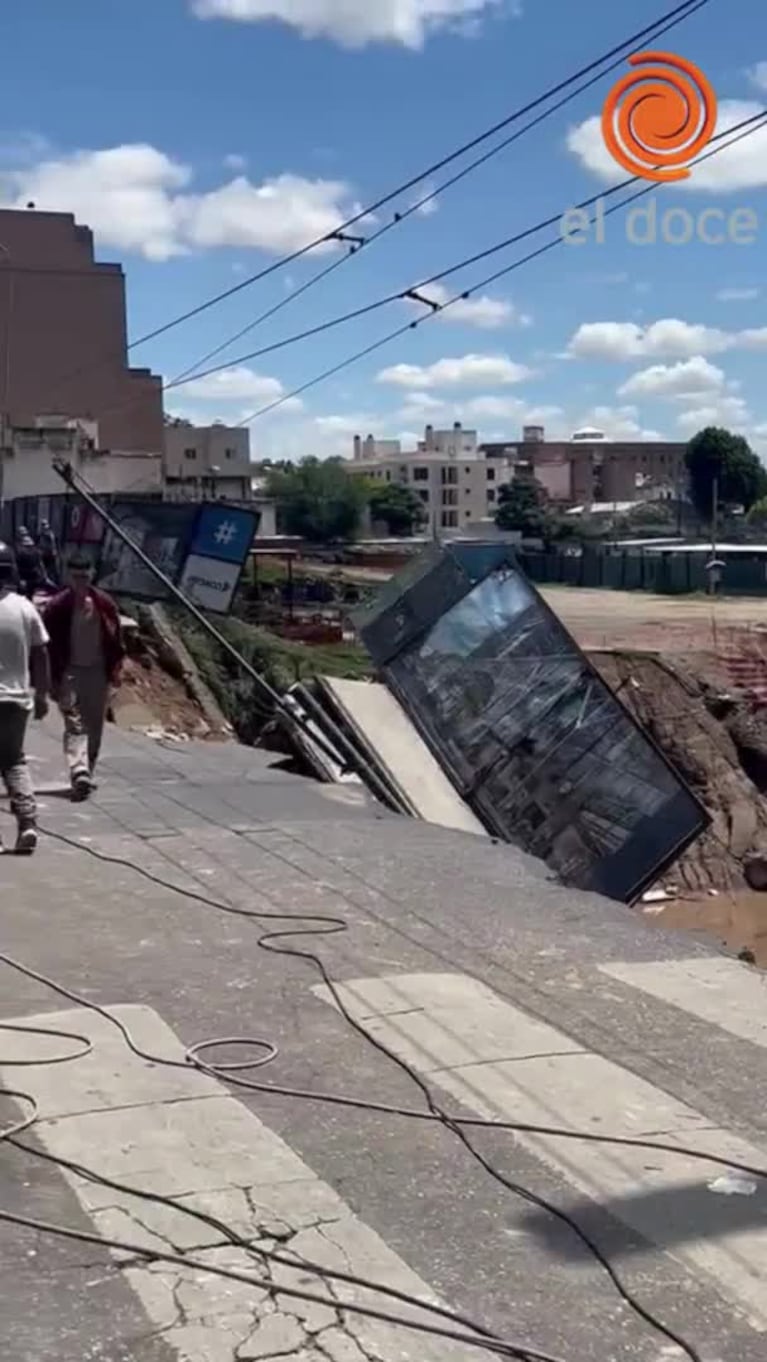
[0,543,50,855]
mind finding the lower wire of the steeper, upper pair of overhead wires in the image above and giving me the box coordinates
[163,0,708,392]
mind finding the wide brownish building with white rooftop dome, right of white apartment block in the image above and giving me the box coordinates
[481,426,687,505]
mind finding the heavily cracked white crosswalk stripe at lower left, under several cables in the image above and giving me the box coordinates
[0,1007,478,1362]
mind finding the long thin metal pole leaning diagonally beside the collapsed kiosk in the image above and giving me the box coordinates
[53,459,403,808]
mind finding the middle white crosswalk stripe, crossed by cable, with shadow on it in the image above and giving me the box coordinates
[315,974,767,1331]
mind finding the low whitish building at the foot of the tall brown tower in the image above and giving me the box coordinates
[0,417,162,505]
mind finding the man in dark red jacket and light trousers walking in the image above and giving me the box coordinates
[44,556,125,799]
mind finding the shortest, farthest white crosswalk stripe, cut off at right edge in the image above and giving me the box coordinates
[599,956,767,1047]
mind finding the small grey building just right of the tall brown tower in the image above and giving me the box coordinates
[163,421,253,501]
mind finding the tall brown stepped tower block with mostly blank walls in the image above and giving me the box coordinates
[0,210,162,455]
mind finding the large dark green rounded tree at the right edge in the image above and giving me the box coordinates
[685,426,767,520]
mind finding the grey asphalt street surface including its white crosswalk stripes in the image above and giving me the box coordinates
[0,720,767,1362]
